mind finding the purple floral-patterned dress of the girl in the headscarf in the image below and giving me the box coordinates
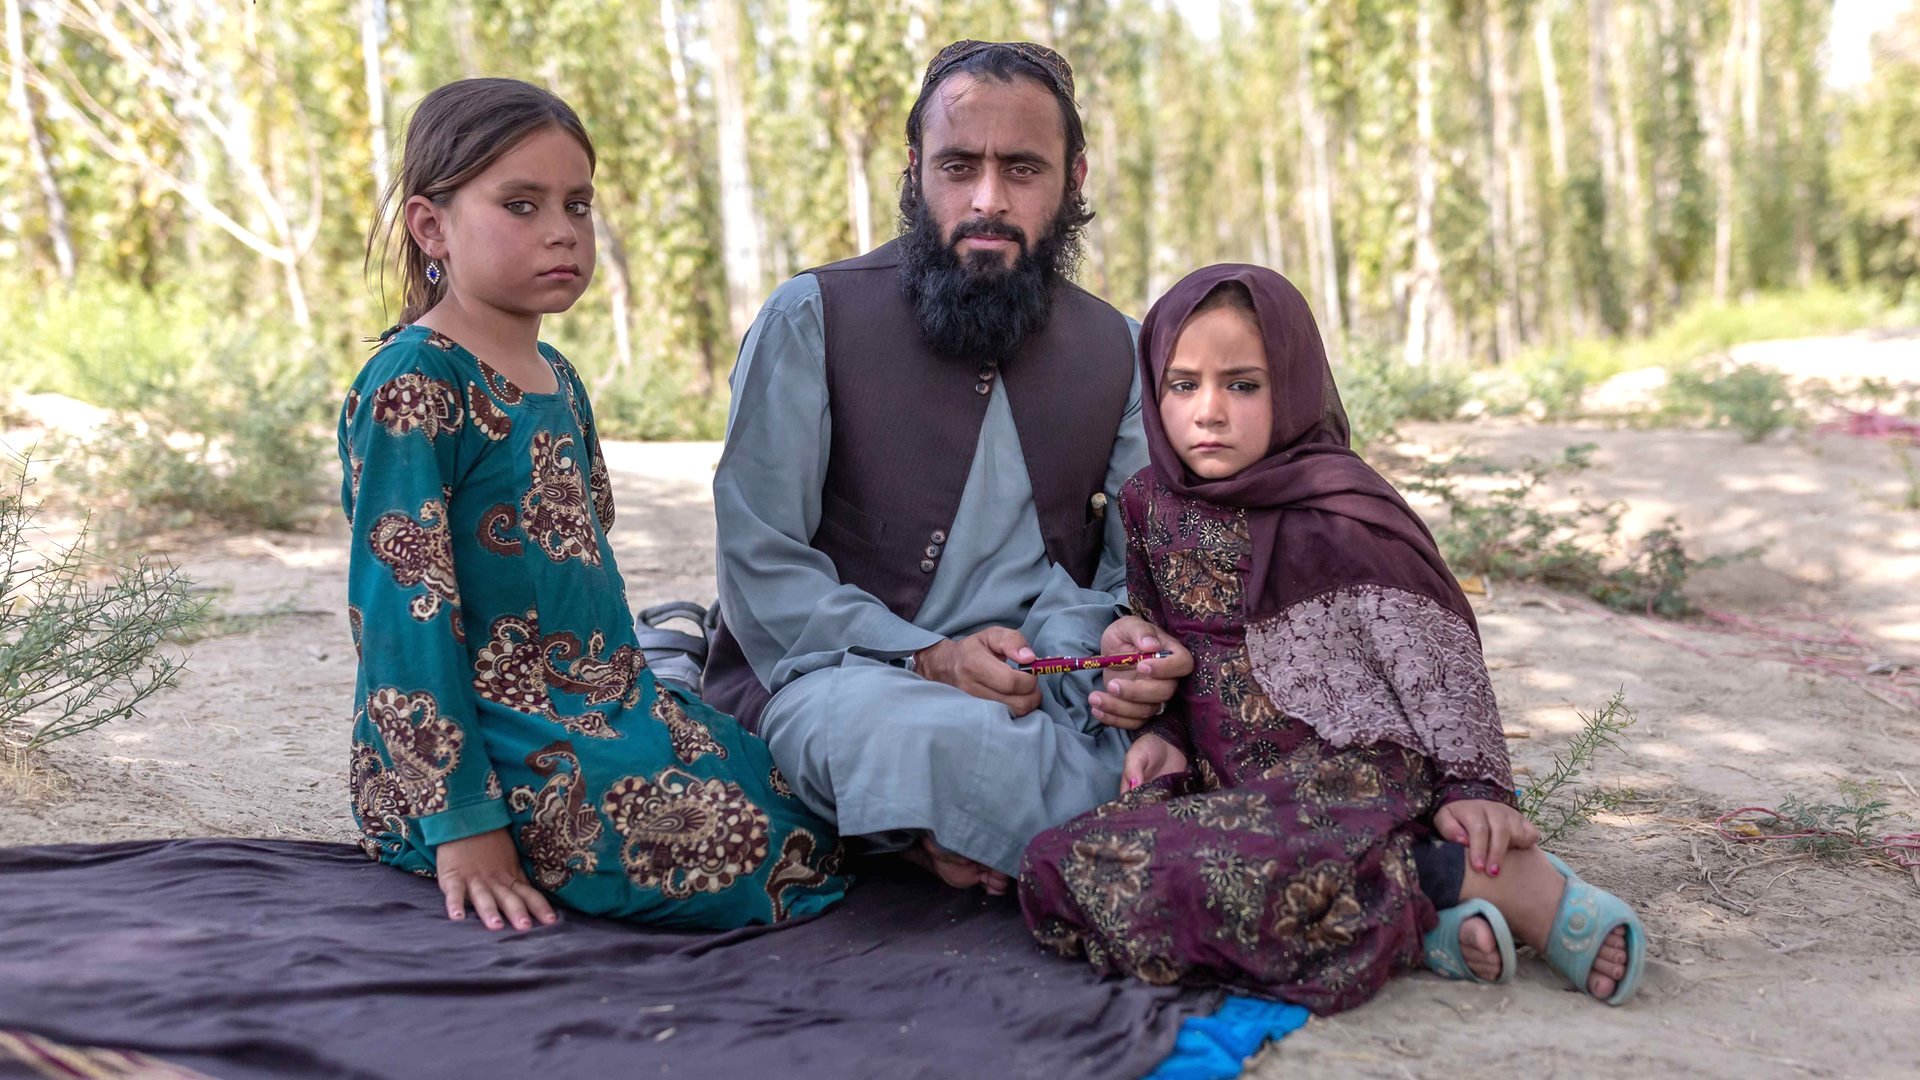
[1020,473,1482,1015]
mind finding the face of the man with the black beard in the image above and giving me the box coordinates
[914,73,1087,273]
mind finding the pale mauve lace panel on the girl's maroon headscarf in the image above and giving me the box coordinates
[1246,584,1513,788]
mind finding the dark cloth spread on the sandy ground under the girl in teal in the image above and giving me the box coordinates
[0,840,1217,1080]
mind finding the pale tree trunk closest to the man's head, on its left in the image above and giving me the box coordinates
[712,0,762,340]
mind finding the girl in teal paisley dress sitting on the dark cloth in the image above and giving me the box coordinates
[340,79,847,928]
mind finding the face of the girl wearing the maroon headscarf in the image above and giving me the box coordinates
[1160,307,1273,480]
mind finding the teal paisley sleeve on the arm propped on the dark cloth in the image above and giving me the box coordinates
[340,344,509,846]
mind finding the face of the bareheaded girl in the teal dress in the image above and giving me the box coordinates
[407,127,593,315]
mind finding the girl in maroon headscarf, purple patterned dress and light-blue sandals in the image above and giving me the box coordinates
[1020,265,1645,1015]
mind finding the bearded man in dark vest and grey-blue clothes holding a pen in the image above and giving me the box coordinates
[705,42,1192,892]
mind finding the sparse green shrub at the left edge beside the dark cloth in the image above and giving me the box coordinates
[0,461,200,757]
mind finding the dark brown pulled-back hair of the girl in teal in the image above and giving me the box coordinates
[367,79,597,323]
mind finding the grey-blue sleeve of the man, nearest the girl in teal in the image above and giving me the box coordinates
[714,275,941,690]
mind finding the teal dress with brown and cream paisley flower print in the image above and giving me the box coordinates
[338,327,847,928]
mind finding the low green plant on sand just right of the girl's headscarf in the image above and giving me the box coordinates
[1407,442,1759,619]
